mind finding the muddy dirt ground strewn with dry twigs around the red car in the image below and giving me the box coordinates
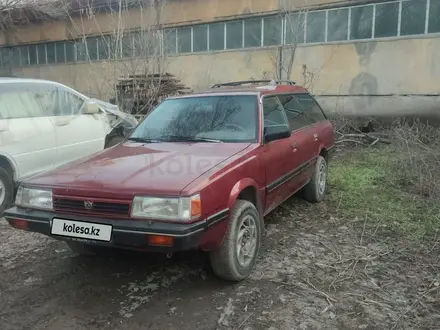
[0,150,440,330]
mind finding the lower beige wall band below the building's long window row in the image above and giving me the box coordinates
[12,37,440,97]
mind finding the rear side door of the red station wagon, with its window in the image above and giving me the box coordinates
[279,94,315,192]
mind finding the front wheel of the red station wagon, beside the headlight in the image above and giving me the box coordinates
[209,200,261,282]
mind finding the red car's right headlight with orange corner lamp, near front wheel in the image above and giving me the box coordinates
[131,195,202,221]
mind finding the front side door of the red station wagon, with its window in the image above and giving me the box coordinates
[262,96,300,212]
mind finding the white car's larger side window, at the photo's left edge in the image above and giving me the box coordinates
[0,84,54,119]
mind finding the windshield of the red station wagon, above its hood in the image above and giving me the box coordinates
[129,95,258,142]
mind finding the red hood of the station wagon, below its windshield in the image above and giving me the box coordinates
[25,141,250,198]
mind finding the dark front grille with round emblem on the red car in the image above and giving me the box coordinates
[53,198,130,216]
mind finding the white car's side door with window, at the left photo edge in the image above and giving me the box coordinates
[0,83,56,180]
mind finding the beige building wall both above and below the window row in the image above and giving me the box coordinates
[0,0,440,113]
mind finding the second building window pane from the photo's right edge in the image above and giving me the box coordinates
[400,0,426,36]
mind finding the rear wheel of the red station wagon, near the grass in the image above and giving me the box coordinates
[303,156,328,203]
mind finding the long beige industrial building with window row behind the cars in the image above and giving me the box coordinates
[0,0,440,113]
